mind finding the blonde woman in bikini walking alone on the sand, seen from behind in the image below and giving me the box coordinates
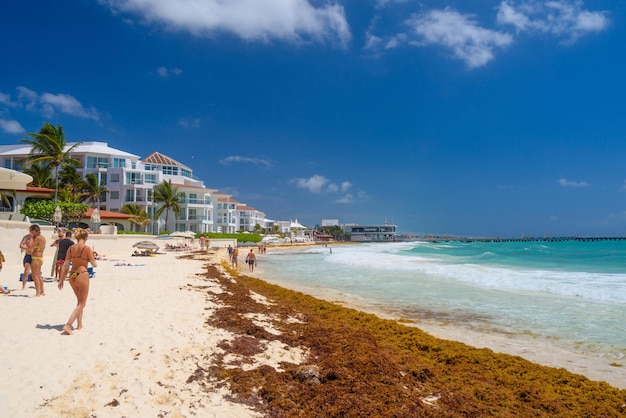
[59,228,97,334]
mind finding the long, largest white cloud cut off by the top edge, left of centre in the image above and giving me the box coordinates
[99,0,351,45]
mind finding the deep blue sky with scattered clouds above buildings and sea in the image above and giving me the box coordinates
[0,0,626,236]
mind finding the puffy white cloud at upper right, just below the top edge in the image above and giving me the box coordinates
[407,8,513,68]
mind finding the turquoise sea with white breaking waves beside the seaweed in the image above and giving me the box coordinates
[252,241,626,384]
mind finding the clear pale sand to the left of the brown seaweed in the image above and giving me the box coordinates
[0,247,258,417]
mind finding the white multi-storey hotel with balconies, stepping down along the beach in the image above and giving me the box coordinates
[0,142,270,234]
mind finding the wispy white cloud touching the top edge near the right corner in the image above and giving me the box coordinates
[497,0,610,43]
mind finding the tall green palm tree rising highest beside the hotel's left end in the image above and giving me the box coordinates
[20,123,82,203]
